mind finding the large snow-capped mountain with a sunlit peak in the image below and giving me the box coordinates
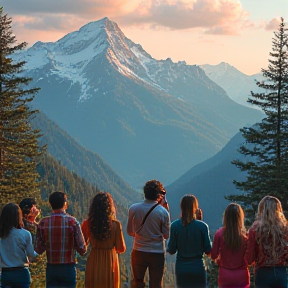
[14,18,262,188]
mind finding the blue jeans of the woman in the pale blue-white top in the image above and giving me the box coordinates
[1,268,31,288]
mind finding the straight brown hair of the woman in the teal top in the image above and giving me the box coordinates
[180,194,198,227]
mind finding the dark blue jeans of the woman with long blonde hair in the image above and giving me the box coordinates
[255,266,287,288]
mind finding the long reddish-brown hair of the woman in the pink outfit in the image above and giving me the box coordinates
[223,203,246,252]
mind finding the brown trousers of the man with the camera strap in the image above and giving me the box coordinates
[130,250,165,288]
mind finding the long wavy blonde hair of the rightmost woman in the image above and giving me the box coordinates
[256,196,287,259]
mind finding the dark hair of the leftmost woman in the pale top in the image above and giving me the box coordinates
[0,203,23,238]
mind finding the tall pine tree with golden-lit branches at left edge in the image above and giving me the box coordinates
[0,7,42,206]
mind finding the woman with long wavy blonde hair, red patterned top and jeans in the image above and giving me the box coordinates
[246,196,288,288]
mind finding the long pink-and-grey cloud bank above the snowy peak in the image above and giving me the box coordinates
[1,0,249,35]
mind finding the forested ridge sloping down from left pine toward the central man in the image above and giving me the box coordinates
[32,112,141,205]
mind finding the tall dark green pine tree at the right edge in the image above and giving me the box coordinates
[227,18,288,223]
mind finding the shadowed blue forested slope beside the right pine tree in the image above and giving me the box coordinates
[166,132,247,234]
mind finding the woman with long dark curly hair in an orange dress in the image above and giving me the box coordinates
[82,192,126,288]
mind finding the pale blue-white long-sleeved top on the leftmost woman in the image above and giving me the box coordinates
[0,228,37,268]
